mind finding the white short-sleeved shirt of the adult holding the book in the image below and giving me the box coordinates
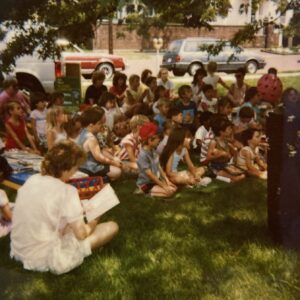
[10,174,83,271]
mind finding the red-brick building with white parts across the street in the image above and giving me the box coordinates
[93,0,293,50]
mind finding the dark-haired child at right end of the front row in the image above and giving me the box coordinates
[237,128,267,179]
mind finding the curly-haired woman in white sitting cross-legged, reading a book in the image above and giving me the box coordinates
[11,141,118,274]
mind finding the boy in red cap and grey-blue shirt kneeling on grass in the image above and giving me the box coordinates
[137,122,177,197]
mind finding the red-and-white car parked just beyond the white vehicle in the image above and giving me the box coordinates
[57,39,125,79]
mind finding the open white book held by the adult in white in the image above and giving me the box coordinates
[81,184,120,222]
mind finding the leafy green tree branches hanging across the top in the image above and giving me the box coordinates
[0,0,299,70]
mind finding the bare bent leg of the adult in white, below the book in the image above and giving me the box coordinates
[87,221,119,249]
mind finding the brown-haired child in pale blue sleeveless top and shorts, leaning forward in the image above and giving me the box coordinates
[78,108,122,180]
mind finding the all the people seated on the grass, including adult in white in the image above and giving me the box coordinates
[0,63,299,274]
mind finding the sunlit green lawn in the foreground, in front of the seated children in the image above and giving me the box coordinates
[0,179,300,300]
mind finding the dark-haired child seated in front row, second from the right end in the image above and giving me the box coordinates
[207,117,245,182]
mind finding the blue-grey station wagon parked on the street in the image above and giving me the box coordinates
[161,38,266,76]
